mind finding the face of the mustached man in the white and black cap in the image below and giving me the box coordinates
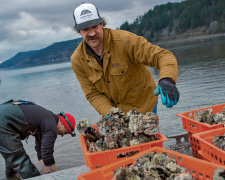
[79,24,103,49]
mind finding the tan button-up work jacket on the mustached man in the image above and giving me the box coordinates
[71,28,178,115]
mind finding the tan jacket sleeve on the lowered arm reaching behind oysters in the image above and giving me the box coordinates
[71,59,113,116]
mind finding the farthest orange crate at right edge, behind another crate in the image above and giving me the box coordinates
[177,103,225,133]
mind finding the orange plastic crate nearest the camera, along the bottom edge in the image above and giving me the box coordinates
[77,147,225,180]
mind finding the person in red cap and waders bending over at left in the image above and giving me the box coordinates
[0,100,76,179]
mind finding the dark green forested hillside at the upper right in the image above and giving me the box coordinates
[120,0,225,41]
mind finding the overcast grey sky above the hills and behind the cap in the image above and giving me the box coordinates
[0,0,181,62]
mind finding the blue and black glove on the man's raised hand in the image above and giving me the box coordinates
[154,78,180,108]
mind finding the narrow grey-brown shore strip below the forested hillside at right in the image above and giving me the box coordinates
[155,33,225,48]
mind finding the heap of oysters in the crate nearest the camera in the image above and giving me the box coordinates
[113,152,192,180]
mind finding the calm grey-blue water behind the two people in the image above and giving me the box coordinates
[0,40,225,179]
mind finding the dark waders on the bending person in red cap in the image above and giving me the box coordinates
[0,104,40,179]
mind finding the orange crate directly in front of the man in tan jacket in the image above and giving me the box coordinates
[80,124,168,169]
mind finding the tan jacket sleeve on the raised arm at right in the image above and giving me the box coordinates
[126,33,178,83]
